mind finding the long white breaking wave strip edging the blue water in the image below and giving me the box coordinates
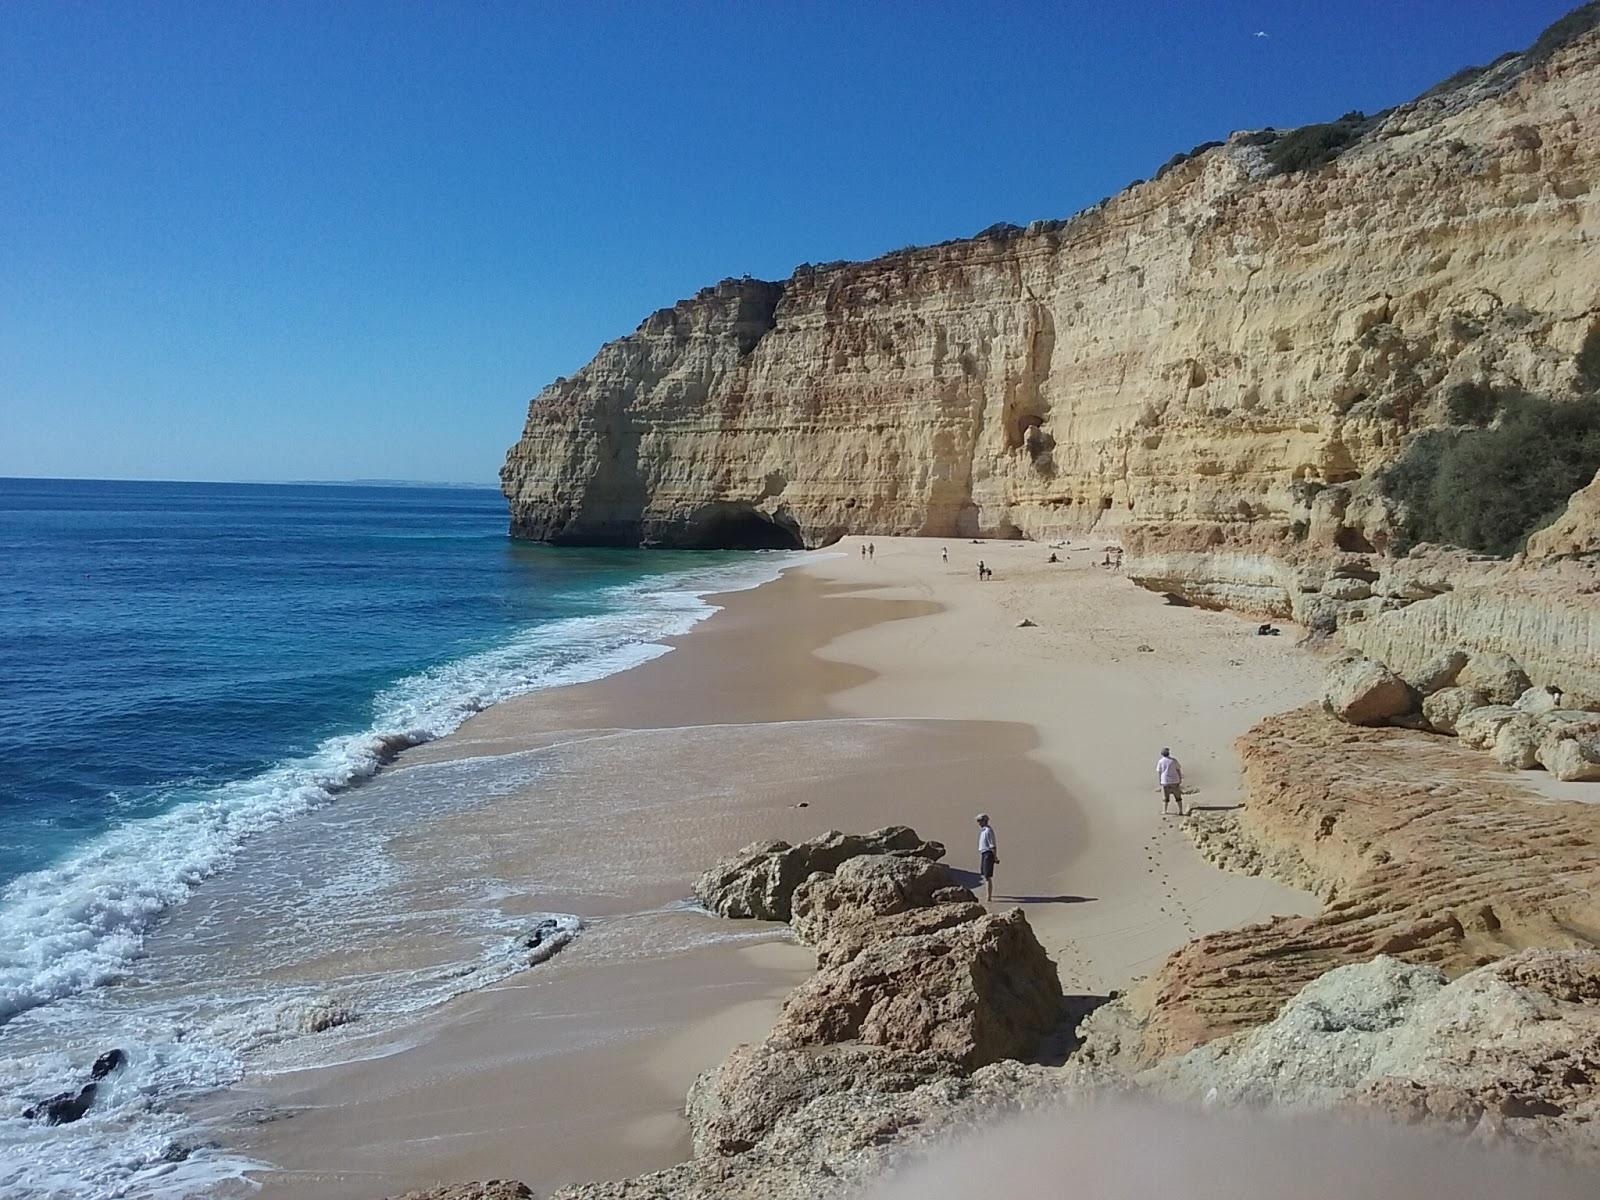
[0,555,794,1026]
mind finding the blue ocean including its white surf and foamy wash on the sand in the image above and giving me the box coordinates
[0,480,789,1200]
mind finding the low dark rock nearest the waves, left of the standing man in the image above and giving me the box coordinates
[694,826,944,922]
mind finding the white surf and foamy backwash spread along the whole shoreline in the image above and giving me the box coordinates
[0,554,798,1200]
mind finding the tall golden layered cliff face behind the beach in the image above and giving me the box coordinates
[502,34,1600,553]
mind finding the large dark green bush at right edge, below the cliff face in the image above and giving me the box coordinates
[1379,395,1600,555]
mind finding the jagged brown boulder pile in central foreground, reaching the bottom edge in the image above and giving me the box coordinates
[558,829,1067,1200]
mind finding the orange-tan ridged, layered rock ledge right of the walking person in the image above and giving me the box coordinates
[1085,709,1600,1069]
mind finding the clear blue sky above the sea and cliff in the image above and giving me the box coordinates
[0,0,1571,482]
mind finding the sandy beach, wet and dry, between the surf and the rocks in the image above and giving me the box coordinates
[235,538,1315,1200]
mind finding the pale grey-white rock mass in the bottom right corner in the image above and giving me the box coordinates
[1138,950,1600,1160]
